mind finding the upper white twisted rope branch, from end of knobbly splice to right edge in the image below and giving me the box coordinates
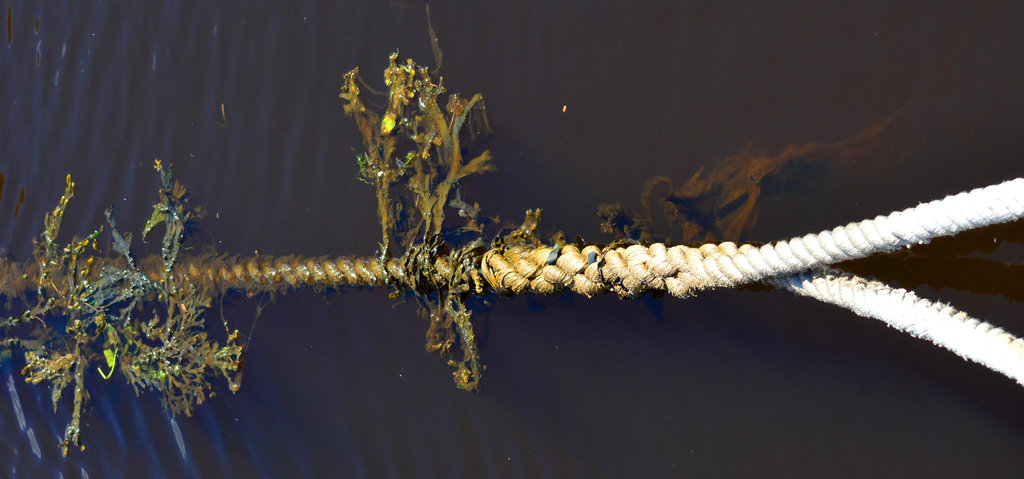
[666,178,1024,297]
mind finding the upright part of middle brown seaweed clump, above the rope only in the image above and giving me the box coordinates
[339,52,494,257]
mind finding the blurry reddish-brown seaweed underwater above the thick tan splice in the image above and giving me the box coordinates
[598,108,905,244]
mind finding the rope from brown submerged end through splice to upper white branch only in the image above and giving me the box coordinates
[6,178,1024,305]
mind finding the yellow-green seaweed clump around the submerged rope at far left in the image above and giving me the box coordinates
[0,161,243,453]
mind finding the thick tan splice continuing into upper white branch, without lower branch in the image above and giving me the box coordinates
[480,178,1024,298]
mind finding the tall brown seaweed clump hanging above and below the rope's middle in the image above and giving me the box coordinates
[340,52,497,390]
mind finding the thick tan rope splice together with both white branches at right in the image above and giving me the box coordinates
[480,178,1024,385]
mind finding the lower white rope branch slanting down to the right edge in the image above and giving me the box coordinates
[769,271,1024,385]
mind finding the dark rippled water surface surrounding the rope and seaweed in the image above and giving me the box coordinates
[0,1,1024,478]
